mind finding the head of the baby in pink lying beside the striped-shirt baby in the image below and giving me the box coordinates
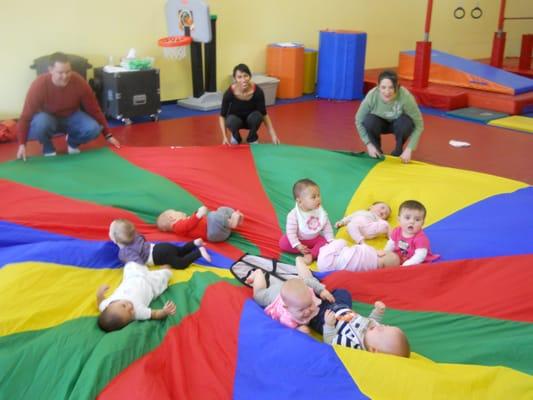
[280,278,318,325]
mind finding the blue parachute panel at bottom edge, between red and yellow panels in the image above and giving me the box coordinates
[233,300,368,400]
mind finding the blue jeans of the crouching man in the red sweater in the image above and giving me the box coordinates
[28,111,103,154]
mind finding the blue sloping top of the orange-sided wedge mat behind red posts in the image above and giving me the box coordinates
[405,50,533,94]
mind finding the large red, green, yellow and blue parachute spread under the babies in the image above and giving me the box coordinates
[0,145,533,399]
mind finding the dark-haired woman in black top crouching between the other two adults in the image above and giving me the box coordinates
[219,64,279,144]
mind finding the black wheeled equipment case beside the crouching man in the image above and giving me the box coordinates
[92,68,161,125]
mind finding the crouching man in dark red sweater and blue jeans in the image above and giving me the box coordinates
[17,53,120,160]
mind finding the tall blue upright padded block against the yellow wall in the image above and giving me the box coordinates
[317,31,366,100]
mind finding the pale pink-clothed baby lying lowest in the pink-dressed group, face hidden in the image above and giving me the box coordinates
[316,239,400,272]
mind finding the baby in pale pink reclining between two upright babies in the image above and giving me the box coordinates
[335,201,391,244]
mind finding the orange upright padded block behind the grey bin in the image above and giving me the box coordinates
[267,43,304,99]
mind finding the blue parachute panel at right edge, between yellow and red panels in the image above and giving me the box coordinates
[425,187,533,261]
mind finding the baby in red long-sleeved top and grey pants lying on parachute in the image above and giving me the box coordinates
[157,206,244,242]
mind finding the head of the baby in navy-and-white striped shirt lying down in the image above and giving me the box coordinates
[364,324,411,357]
